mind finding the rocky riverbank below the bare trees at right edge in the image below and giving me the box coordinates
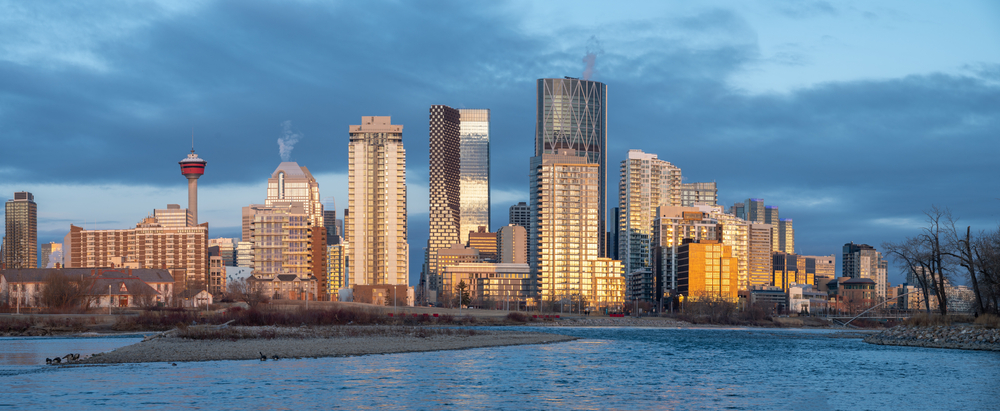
[864,325,1000,351]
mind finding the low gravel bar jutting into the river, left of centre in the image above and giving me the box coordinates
[75,326,576,364]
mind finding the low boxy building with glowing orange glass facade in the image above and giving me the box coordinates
[677,240,739,302]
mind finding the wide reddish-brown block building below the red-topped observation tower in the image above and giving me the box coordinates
[63,217,210,298]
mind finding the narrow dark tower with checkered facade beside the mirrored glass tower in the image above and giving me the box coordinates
[422,105,468,290]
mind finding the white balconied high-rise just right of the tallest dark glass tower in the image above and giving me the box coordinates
[618,150,681,298]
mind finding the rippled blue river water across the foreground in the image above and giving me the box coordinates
[0,327,1000,410]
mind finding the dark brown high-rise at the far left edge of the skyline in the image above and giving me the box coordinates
[3,191,38,268]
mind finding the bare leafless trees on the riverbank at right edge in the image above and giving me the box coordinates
[882,206,1000,315]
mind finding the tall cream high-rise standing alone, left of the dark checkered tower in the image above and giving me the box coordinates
[344,116,410,286]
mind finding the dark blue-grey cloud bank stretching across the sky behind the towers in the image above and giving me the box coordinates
[0,2,1000,286]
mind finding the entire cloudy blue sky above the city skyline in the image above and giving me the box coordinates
[0,1,1000,283]
